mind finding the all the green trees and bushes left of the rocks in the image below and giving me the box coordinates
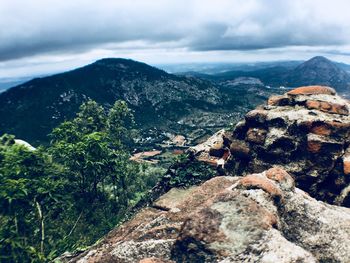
[0,101,157,262]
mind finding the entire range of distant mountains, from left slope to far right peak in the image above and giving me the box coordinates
[0,57,350,145]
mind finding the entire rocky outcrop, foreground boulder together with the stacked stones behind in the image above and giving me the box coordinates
[61,86,350,263]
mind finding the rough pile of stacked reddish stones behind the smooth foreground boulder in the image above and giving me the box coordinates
[224,86,350,206]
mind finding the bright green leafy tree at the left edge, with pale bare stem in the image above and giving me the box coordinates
[0,135,66,262]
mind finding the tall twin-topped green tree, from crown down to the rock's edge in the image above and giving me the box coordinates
[48,101,145,253]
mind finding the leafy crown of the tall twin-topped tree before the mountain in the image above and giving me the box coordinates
[49,101,142,206]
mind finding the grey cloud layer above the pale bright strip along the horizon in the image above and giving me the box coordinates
[0,0,350,61]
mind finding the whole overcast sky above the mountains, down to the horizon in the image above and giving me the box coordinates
[0,0,350,79]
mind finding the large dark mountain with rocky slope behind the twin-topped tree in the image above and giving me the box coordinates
[0,58,227,142]
